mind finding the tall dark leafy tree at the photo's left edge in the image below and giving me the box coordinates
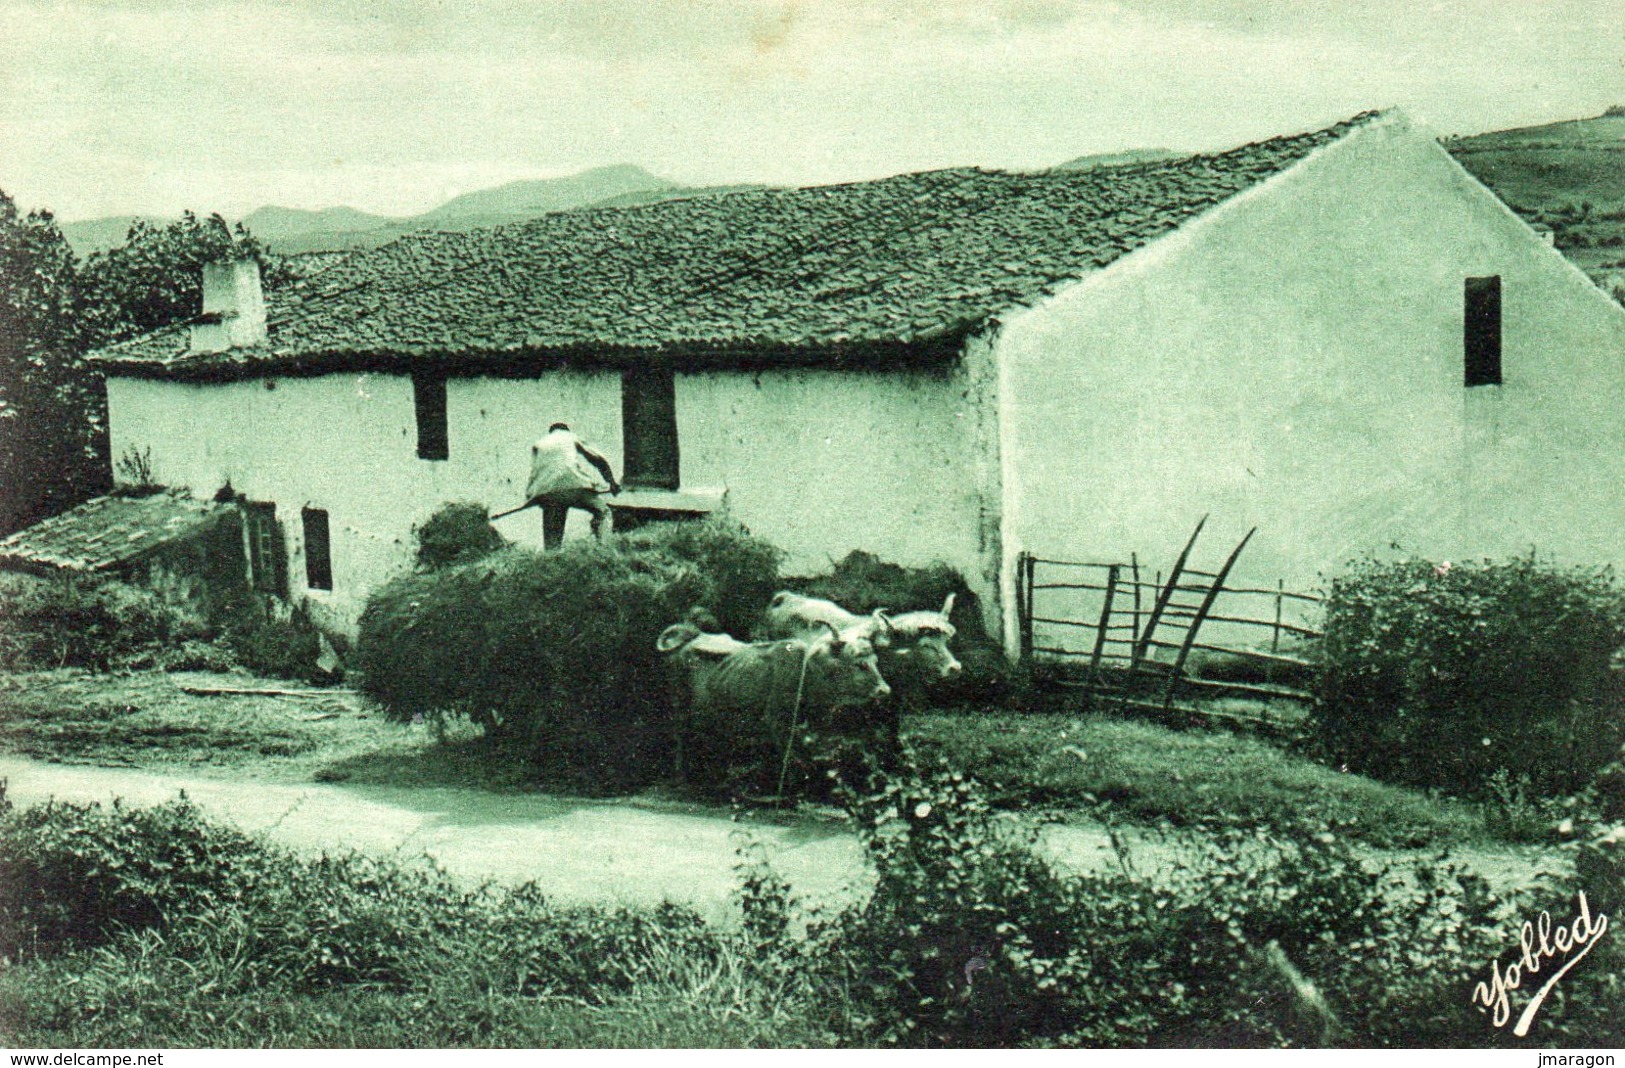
[0,190,109,532]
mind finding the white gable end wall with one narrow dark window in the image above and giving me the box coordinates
[995,119,1625,653]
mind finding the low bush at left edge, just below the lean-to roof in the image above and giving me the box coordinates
[0,574,210,671]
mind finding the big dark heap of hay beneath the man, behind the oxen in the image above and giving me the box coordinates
[354,522,778,790]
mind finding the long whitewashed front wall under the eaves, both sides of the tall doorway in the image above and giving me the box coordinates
[109,371,996,626]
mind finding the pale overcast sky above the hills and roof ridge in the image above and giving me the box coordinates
[0,0,1625,219]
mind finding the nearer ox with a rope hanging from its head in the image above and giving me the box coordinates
[655,623,892,782]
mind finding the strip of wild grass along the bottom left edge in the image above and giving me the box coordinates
[0,935,835,1048]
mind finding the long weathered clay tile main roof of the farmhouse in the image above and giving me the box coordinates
[96,112,1378,377]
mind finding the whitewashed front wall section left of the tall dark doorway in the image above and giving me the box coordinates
[107,372,621,626]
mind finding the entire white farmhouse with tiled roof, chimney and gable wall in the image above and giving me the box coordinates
[82,112,1625,653]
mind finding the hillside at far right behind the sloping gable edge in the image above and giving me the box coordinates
[1445,107,1625,296]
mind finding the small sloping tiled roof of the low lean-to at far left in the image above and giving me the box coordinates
[0,491,229,572]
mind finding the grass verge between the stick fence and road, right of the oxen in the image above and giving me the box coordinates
[904,714,1485,847]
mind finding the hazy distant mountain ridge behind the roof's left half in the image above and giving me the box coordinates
[62,164,708,255]
